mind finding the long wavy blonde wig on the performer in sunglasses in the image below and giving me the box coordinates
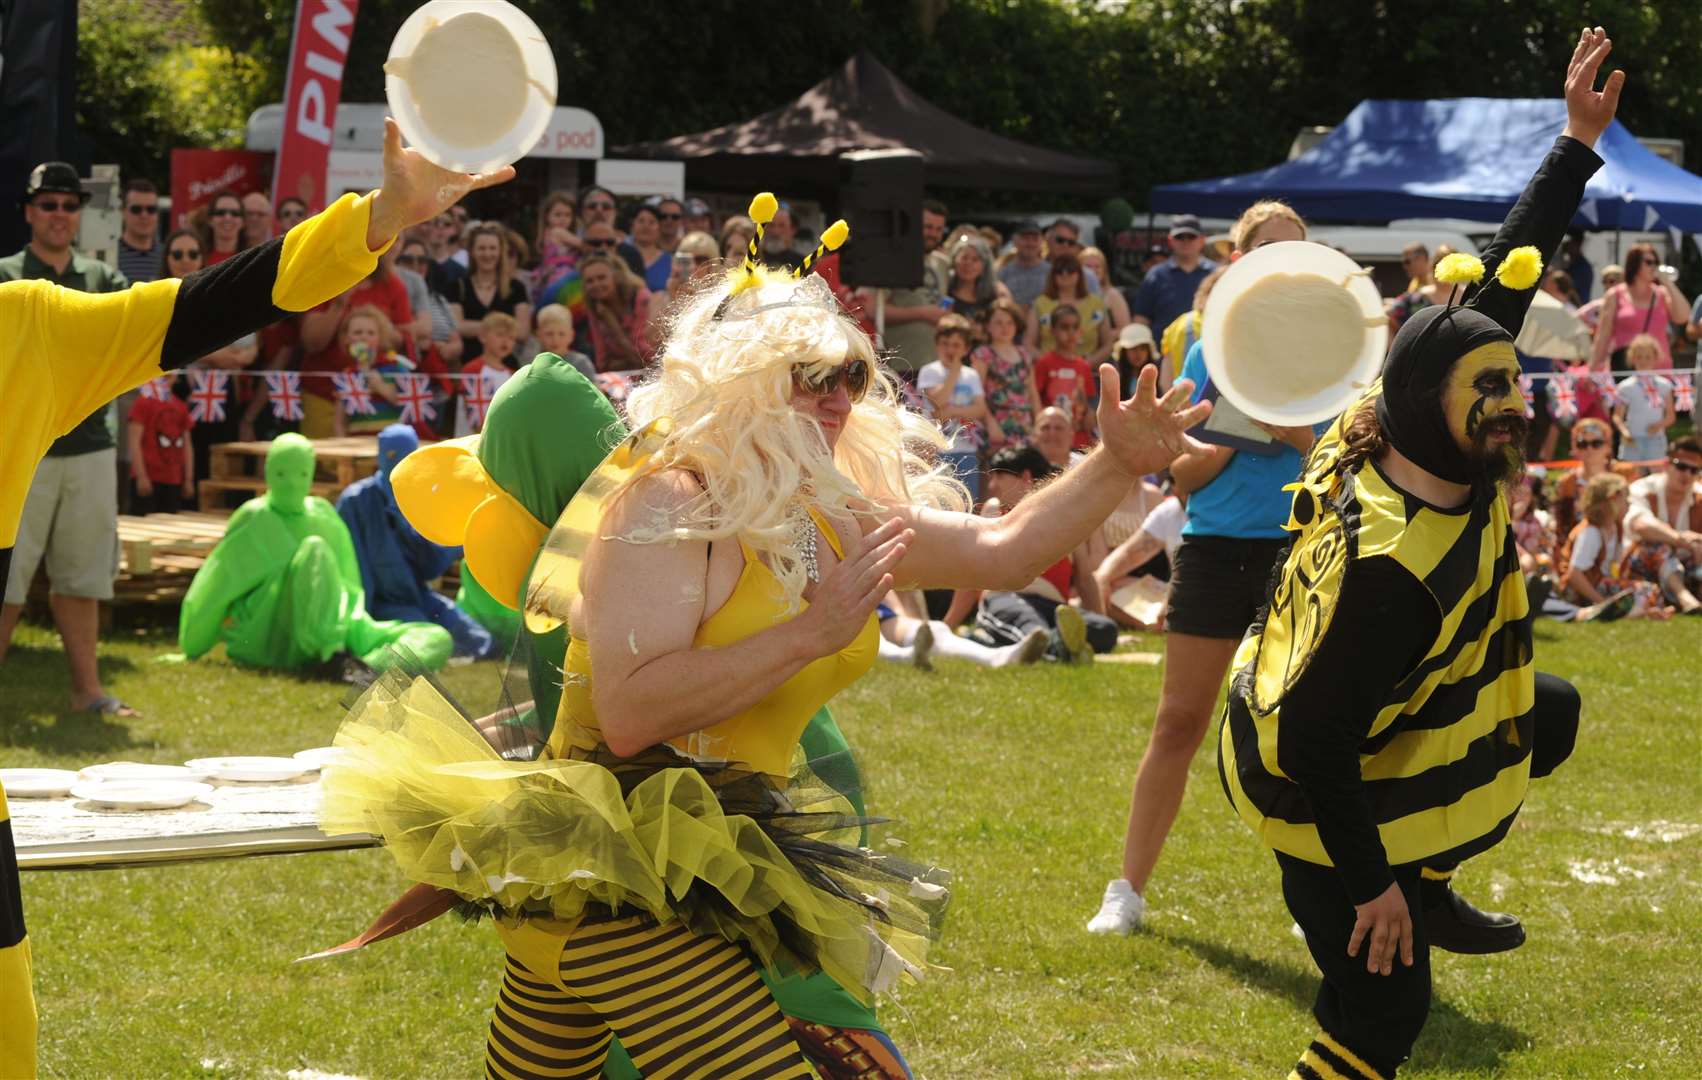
[623,269,968,605]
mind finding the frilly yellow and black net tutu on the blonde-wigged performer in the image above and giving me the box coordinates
[320,670,948,1002]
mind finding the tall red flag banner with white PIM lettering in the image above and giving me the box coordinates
[272,0,359,213]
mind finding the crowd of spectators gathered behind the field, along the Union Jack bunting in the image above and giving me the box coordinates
[0,163,1702,713]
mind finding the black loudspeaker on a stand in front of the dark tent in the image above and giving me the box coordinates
[839,150,922,335]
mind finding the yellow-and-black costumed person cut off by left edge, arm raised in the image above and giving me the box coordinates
[0,121,514,1080]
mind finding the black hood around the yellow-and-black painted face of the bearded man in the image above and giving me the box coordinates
[1377,306,1530,483]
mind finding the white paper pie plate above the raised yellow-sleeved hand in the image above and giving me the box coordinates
[385,0,555,172]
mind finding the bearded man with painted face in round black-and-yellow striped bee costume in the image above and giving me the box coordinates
[1219,29,1624,1080]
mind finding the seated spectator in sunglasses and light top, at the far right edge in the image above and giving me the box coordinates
[1625,435,1702,616]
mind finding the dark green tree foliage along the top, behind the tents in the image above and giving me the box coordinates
[80,0,1702,204]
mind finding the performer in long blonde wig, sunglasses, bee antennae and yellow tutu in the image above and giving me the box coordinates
[323,196,1207,1078]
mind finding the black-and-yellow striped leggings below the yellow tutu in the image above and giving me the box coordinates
[485,917,815,1080]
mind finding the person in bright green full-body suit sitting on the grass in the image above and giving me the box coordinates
[177,434,454,670]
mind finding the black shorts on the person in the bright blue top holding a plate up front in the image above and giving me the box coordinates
[1164,536,1288,641]
